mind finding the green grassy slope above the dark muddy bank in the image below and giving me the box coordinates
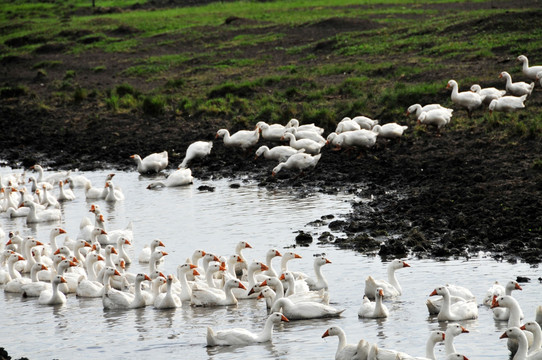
[0,0,542,136]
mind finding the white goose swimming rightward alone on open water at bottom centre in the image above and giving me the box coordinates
[207,312,289,346]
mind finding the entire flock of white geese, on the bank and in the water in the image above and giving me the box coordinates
[0,56,542,360]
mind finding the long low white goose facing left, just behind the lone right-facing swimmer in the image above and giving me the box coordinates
[271,297,345,320]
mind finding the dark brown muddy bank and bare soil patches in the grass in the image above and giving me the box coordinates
[0,1,542,263]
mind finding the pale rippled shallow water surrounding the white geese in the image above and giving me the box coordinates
[0,169,542,359]
